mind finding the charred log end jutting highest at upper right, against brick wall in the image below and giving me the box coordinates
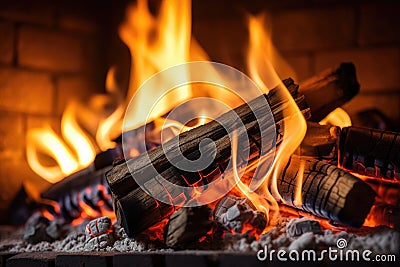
[300,63,360,122]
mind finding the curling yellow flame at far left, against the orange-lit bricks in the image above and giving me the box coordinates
[26,68,125,183]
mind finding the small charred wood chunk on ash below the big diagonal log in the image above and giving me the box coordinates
[164,206,214,248]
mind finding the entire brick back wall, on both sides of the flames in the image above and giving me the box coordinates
[0,0,400,221]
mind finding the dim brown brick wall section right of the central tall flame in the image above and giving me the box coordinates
[193,0,400,130]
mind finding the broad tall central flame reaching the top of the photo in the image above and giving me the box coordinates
[119,0,192,128]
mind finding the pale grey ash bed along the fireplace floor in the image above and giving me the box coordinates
[0,218,400,254]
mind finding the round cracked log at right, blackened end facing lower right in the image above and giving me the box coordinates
[278,156,375,227]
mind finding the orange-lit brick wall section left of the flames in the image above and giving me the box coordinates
[0,1,110,218]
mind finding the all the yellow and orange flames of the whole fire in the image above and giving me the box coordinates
[27,0,366,238]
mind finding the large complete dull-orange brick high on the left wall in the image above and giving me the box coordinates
[18,26,93,72]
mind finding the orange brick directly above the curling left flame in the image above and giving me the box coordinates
[56,76,99,114]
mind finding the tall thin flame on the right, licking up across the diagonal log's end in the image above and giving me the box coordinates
[232,16,307,228]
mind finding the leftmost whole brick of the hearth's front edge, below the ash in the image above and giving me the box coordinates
[7,252,56,267]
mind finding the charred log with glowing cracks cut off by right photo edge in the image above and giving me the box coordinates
[339,126,400,180]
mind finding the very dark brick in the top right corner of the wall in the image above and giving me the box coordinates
[359,1,400,45]
